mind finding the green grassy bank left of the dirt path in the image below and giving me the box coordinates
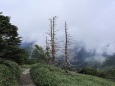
[0,60,21,86]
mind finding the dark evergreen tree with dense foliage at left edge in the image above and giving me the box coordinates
[0,13,27,63]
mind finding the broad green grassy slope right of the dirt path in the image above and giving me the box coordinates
[30,63,115,86]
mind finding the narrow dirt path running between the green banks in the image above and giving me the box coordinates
[19,68,36,86]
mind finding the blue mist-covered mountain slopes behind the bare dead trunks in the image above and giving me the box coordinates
[21,42,115,68]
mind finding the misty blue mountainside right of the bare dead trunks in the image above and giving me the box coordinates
[69,42,115,68]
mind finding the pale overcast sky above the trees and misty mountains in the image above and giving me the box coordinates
[0,0,115,54]
